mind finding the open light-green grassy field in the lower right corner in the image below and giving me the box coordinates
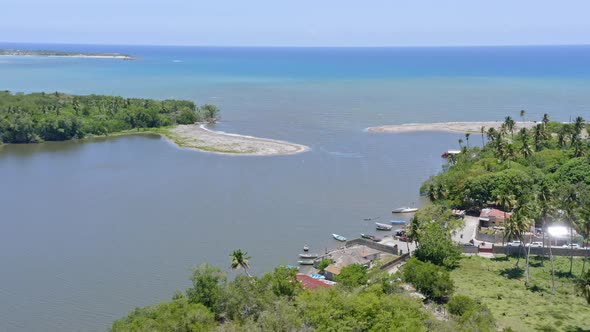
[452,256,590,331]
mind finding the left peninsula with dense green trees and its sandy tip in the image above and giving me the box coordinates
[0,91,308,156]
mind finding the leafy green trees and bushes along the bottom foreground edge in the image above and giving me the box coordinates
[111,250,495,332]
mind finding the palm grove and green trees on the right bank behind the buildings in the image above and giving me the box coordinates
[421,111,590,294]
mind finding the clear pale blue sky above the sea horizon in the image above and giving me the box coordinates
[0,0,590,46]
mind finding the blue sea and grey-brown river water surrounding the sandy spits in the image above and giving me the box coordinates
[0,45,590,331]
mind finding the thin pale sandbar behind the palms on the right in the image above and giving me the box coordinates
[366,121,537,133]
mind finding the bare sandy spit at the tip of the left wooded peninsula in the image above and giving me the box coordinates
[166,124,309,156]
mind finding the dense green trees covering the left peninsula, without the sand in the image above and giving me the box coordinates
[0,91,219,143]
